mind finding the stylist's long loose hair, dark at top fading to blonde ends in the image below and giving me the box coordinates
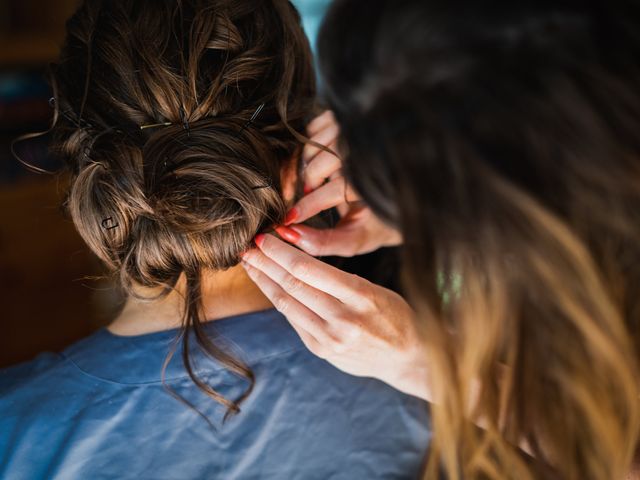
[319,0,640,480]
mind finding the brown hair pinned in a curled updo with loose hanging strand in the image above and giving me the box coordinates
[45,0,315,413]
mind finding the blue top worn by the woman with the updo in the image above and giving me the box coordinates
[0,310,430,480]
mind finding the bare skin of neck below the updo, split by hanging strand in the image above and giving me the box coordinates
[107,265,273,336]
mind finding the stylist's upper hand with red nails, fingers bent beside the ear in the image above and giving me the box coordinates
[278,111,402,257]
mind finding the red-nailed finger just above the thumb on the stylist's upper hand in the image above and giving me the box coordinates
[285,177,358,225]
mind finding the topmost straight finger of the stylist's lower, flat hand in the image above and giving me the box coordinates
[248,235,368,304]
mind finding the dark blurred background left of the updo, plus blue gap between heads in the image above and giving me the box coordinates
[0,0,336,368]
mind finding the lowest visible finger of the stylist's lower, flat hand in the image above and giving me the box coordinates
[243,263,328,347]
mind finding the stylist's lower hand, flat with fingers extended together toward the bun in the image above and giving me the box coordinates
[243,235,430,400]
